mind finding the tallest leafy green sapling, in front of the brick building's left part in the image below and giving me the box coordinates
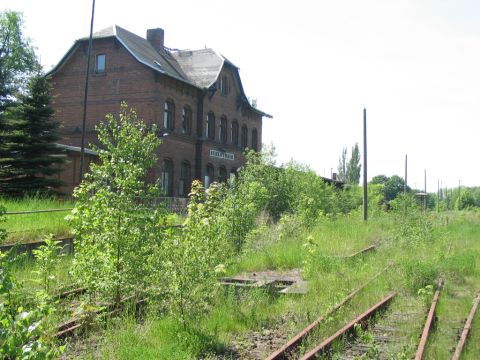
[70,103,166,305]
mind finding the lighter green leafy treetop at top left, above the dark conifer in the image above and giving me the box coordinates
[0,10,39,109]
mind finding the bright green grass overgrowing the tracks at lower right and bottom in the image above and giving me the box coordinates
[9,208,480,359]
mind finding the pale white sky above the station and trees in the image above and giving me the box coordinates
[1,0,480,192]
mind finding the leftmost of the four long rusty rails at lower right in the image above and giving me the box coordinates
[267,263,394,360]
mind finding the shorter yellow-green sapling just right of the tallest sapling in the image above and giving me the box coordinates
[158,180,229,329]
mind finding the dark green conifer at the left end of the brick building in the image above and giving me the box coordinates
[0,75,64,196]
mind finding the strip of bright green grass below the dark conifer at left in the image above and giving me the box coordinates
[0,197,74,243]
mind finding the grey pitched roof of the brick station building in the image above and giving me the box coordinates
[47,25,271,117]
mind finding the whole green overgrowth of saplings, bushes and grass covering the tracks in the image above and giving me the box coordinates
[0,105,480,359]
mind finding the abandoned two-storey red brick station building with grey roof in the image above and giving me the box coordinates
[47,26,271,196]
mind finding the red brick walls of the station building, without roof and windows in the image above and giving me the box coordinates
[50,26,266,196]
